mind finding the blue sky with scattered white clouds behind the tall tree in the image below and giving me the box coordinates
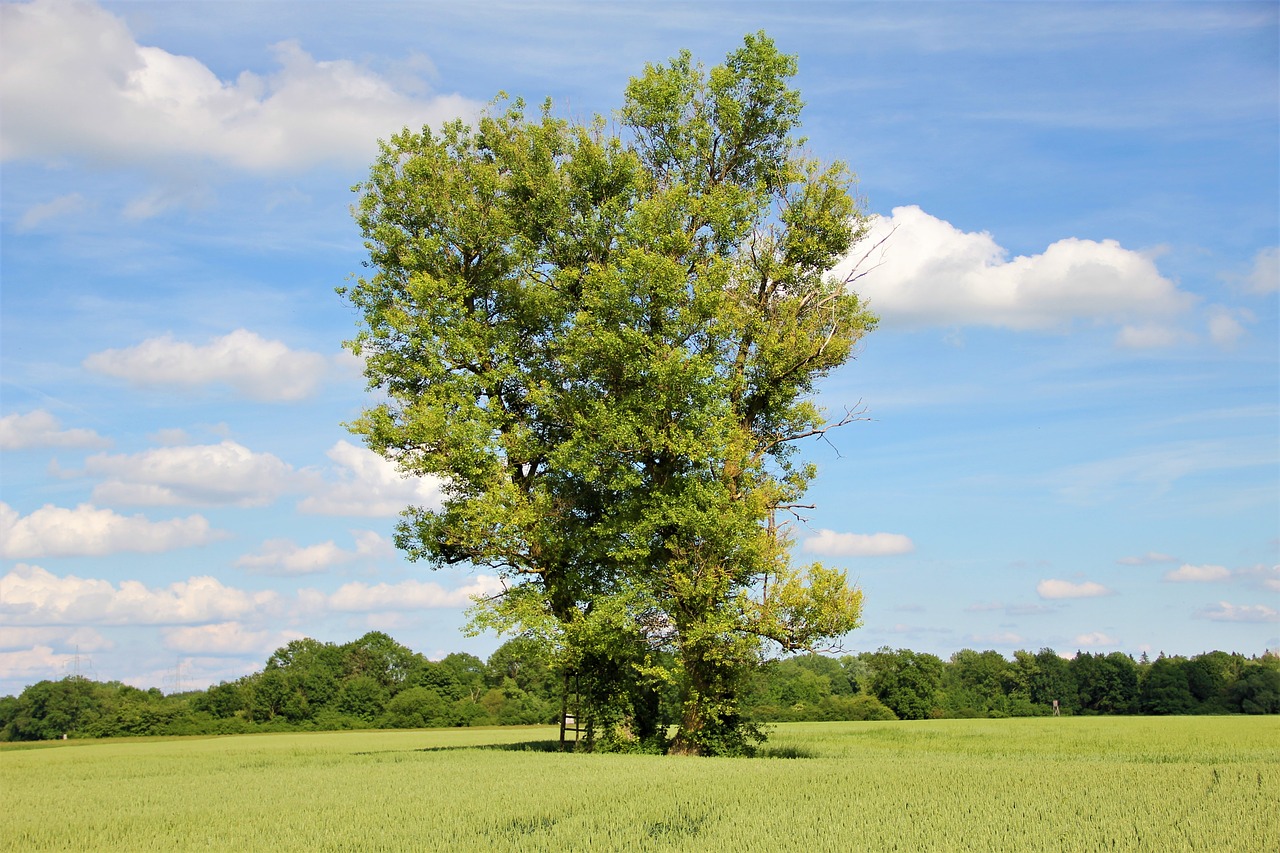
[0,0,1280,693]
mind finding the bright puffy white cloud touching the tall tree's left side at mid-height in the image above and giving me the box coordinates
[298,441,440,516]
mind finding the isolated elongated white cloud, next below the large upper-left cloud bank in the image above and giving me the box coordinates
[84,329,330,402]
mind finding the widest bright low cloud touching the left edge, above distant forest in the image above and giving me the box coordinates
[0,564,279,625]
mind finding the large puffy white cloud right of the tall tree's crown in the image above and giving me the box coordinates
[836,206,1194,333]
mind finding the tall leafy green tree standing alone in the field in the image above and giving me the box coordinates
[344,33,876,753]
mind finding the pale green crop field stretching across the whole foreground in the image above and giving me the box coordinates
[0,717,1280,853]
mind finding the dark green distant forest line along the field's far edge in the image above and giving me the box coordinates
[0,631,1280,740]
